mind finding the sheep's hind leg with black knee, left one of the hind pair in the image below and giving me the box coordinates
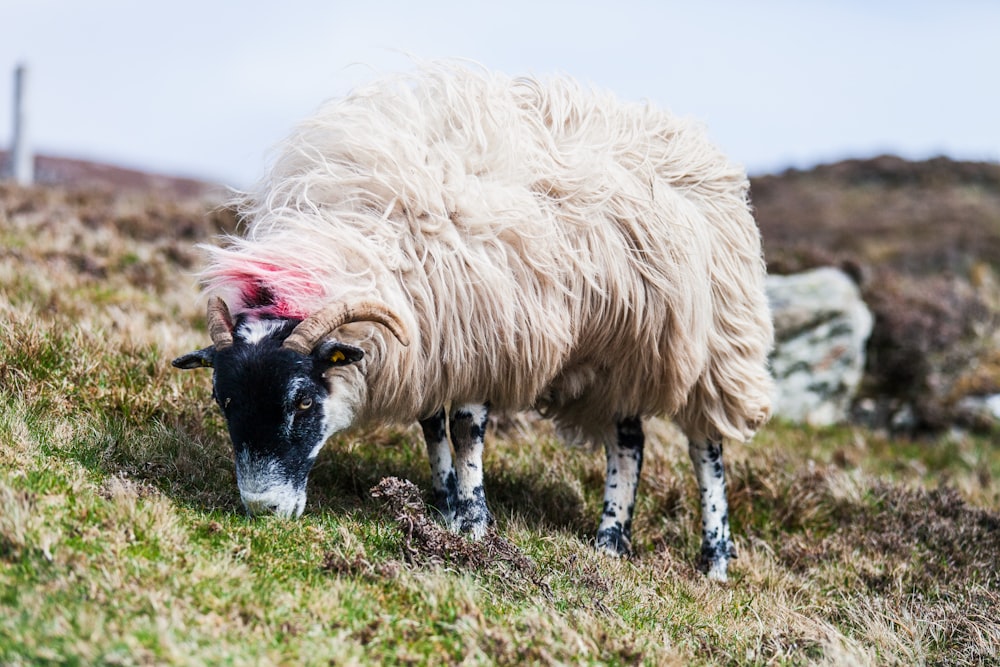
[597,417,646,556]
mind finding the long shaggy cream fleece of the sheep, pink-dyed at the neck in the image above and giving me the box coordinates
[202,64,773,440]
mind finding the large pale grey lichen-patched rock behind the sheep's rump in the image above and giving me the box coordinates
[767,268,873,426]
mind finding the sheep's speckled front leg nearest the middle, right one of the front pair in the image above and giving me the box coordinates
[451,404,493,539]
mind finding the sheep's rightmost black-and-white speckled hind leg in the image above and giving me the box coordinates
[688,438,736,581]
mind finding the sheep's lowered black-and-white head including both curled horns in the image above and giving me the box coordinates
[173,297,408,516]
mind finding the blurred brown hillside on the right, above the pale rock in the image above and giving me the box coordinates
[752,156,1000,275]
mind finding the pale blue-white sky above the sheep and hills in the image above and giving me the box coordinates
[0,0,1000,187]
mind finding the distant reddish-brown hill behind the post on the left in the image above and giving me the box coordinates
[0,151,223,199]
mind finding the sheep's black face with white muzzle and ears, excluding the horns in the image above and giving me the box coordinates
[174,321,364,517]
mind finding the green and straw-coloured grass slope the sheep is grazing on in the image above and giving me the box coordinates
[0,180,1000,665]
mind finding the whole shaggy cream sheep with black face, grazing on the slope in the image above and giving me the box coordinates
[174,63,773,580]
